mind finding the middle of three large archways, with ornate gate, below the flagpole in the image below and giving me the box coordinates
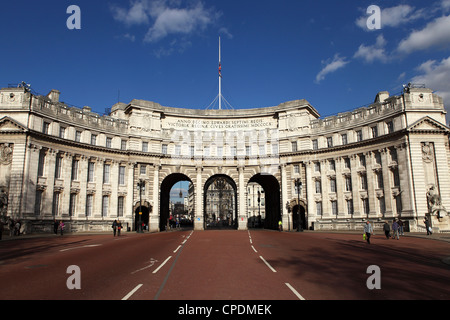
[203,174,238,229]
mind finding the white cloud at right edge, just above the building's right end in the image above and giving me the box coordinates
[411,57,450,109]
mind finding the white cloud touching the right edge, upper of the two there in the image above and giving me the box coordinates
[398,16,450,53]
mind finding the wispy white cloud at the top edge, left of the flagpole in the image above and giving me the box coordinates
[111,0,220,42]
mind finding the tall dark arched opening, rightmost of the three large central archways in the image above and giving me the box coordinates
[247,174,281,230]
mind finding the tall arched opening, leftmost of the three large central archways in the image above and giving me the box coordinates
[159,173,194,231]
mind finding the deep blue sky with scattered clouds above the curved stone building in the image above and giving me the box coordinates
[0,0,450,116]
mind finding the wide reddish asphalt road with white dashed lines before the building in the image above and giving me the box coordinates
[0,230,450,300]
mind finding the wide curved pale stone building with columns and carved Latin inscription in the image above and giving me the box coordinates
[0,85,450,232]
